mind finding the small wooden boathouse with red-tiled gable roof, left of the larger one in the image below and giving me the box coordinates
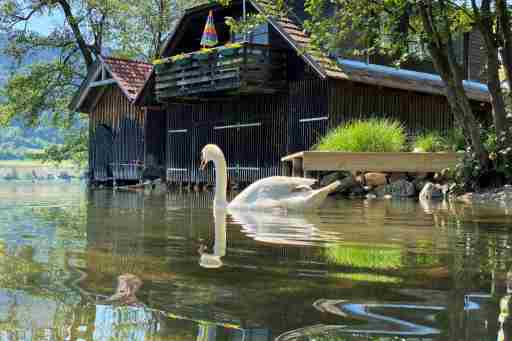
[71,57,152,182]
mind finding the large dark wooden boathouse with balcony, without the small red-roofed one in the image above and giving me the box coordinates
[136,0,490,183]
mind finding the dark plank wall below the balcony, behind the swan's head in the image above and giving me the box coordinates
[167,95,288,183]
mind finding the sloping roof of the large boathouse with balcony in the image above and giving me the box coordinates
[135,0,490,104]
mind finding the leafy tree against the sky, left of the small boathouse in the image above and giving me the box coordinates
[0,0,192,165]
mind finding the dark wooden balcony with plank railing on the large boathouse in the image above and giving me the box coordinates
[155,44,286,103]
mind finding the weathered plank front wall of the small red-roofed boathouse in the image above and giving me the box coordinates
[89,87,144,181]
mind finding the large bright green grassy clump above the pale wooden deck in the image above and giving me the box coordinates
[314,118,406,152]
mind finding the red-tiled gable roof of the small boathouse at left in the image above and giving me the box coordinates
[70,57,153,113]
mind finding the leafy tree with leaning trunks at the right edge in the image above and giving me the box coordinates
[305,0,512,177]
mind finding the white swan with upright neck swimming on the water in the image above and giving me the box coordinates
[200,144,340,210]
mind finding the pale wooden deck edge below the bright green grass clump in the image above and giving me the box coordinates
[281,151,464,176]
